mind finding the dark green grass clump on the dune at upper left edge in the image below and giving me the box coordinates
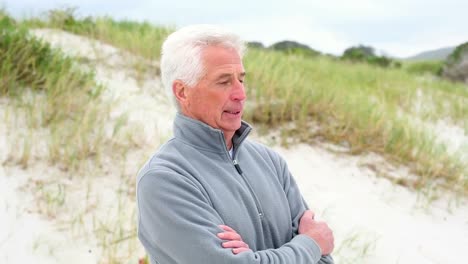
[0,11,93,95]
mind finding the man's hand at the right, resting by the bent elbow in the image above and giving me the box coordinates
[299,210,335,255]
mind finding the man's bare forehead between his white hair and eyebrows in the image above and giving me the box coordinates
[202,46,244,74]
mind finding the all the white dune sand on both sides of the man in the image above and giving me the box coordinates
[0,30,468,263]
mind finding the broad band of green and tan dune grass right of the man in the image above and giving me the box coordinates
[245,49,468,192]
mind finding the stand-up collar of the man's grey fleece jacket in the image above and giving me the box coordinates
[174,113,252,152]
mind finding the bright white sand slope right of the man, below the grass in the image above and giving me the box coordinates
[278,145,468,263]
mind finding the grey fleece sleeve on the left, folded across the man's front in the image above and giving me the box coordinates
[137,170,321,264]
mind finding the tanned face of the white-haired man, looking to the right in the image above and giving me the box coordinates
[181,46,246,134]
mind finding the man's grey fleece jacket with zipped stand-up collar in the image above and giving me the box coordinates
[137,114,333,264]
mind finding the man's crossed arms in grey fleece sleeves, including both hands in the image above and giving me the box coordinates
[137,165,333,264]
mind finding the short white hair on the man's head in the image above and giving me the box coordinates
[161,25,245,109]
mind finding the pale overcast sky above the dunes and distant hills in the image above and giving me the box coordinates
[0,0,468,57]
